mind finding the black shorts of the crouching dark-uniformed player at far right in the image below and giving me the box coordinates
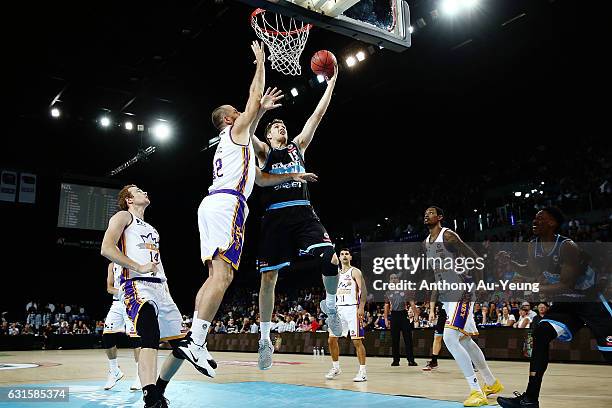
[540,302,612,353]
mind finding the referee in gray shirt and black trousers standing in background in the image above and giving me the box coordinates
[384,274,418,367]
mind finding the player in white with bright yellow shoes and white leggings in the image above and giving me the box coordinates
[423,207,504,407]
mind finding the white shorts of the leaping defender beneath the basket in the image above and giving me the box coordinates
[198,193,249,269]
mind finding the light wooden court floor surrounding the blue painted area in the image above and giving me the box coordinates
[0,349,612,408]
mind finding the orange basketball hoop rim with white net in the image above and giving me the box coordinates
[251,8,312,75]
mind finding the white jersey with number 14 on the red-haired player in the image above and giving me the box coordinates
[119,213,166,284]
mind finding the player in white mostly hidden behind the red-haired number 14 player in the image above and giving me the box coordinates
[102,262,141,391]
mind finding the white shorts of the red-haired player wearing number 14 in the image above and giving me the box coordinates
[123,278,186,341]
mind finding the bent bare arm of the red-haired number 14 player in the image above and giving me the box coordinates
[100,211,157,273]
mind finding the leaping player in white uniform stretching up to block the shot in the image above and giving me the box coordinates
[178,41,316,378]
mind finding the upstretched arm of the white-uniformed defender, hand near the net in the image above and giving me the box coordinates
[232,41,266,145]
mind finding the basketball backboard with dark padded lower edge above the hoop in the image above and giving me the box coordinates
[239,0,410,52]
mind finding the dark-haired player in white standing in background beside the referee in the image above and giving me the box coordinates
[325,248,368,382]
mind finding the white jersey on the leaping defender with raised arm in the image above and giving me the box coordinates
[208,126,255,199]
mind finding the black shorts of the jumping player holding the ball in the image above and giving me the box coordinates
[259,205,333,272]
